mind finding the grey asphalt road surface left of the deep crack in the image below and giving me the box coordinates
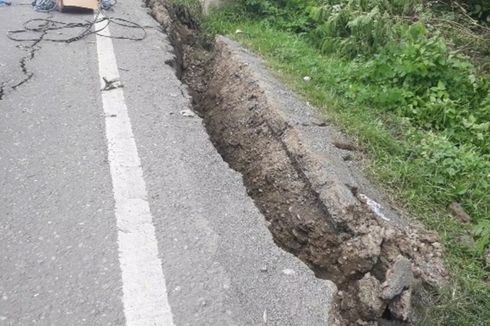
[0,0,332,326]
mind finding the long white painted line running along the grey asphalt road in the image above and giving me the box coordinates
[95,16,174,326]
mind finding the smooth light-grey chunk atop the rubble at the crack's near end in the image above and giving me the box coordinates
[382,255,413,300]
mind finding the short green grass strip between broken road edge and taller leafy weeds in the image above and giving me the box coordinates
[203,10,490,326]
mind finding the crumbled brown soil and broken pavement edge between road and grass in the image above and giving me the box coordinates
[147,0,447,325]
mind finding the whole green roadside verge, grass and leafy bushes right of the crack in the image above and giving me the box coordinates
[190,0,490,325]
